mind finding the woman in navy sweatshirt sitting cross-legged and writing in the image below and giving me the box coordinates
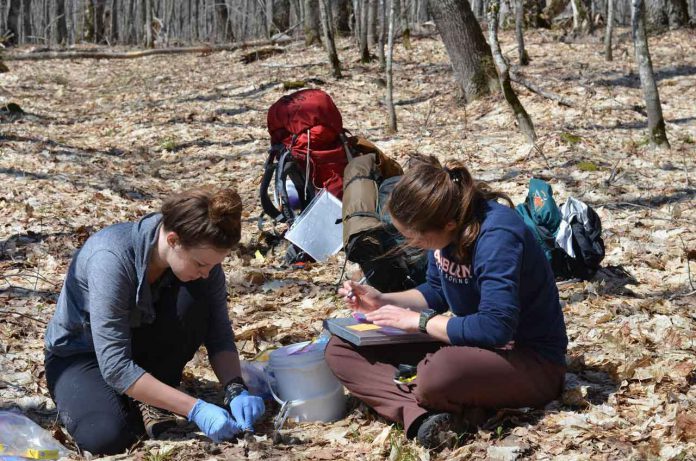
[326,157,568,448]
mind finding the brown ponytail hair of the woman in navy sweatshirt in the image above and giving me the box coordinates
[387,155,513,263]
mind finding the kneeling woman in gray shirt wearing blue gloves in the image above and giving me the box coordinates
[45,189,264,454]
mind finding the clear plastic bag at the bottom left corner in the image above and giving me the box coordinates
[0,411,70,460]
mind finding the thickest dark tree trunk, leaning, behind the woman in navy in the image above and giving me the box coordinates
[428,0,499,102]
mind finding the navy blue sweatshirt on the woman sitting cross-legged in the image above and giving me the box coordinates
[417,201,568,364]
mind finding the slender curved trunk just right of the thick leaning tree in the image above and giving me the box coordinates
[488,0,536,144]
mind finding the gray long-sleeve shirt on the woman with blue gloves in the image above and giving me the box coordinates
[45,213,237,393]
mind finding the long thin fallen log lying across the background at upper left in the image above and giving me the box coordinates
[3,40,273,61]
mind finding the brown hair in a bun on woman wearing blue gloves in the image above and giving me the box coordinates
[162,189,242,249]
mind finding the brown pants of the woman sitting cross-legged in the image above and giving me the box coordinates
[325,336,565,433]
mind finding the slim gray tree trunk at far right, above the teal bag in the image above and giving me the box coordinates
[631,0,669,147]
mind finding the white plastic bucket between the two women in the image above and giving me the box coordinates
[267,341,346,426]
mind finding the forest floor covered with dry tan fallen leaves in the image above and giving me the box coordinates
[0,29,696,460]
